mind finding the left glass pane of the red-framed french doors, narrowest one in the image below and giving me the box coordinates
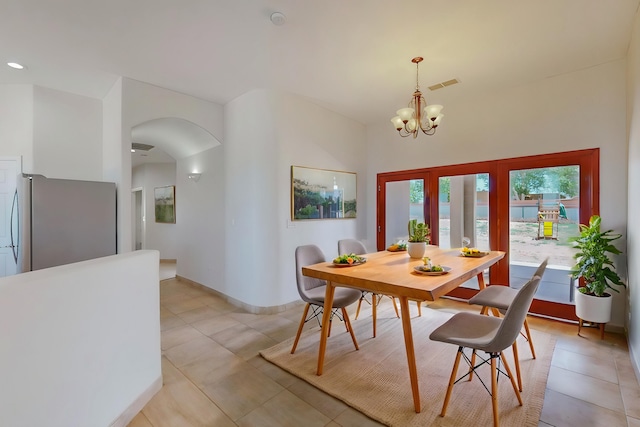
[385,179,424,247]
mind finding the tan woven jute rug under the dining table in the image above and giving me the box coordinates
[260,307,555,427]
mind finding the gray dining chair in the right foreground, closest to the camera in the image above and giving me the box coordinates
[429,276,540,427]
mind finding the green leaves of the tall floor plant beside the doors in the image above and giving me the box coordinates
[570,215,626,297]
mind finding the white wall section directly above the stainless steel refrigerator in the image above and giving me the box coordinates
[32,86,102,181]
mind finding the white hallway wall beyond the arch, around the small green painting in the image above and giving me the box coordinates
[131,163,178,259]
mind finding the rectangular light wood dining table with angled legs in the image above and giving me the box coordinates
[302,246,505,413]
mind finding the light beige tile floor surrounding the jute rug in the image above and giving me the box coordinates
[129,266,640,427]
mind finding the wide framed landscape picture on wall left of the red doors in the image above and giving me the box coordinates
[291,166,357,221]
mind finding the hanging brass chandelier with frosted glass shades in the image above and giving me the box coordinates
[391,56,444,138]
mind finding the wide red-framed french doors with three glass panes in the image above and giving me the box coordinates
[377,149,599,320]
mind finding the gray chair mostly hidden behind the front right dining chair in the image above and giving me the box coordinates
[469,257,549,391]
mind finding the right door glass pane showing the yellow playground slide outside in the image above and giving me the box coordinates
[509,165,580,303]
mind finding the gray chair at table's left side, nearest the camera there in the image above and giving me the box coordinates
[291,245,362,354]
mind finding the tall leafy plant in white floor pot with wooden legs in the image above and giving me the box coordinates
[571,215,626,334]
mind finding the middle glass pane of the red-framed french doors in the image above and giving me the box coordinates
[437,173,490,289]
